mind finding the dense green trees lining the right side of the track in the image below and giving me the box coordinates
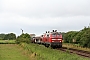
[63,27,90,48]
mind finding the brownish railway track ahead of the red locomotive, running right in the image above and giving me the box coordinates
[57,47,90,58]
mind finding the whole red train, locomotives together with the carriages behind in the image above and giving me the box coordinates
[31,30,63,48]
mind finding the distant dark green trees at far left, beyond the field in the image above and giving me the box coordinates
[0,33,16,40]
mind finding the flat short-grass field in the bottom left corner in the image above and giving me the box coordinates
[0,44,30,60]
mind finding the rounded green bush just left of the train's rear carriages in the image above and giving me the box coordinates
[16,33,31,44]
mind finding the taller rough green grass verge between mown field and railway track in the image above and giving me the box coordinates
[21,43,90,60]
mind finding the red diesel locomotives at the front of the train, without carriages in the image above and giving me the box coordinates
[41,30,63,48]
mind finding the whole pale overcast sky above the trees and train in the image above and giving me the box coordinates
[0,0,90,35]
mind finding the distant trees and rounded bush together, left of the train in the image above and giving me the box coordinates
[0,33,31,44]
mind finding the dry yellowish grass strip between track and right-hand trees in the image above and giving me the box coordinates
[63,43,90,51]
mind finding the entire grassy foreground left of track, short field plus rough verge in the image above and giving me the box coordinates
[0,39,90,60]
